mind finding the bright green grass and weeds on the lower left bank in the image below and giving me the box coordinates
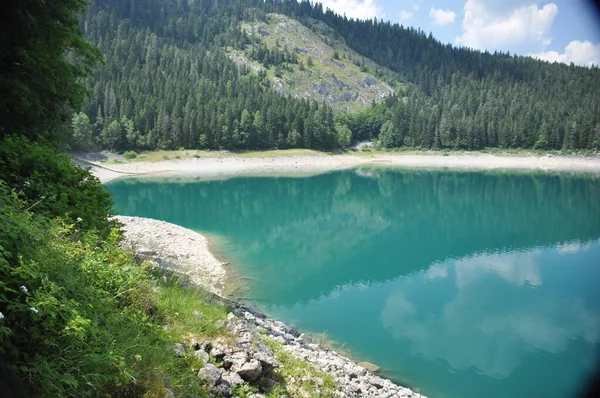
[0,185,226,397]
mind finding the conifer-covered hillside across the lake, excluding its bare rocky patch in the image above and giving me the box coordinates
[73,0,600,150]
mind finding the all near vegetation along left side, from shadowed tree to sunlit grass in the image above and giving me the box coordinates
[0,0,226,397]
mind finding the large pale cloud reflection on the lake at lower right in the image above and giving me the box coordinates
[380,253,600,379]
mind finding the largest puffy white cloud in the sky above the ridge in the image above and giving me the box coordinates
[456,0,558,53]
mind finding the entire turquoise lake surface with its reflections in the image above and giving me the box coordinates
[106,169,600,398]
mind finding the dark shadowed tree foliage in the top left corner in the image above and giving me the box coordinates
[0,0,101,140]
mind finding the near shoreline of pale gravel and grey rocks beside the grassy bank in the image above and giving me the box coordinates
[115,216,424,398]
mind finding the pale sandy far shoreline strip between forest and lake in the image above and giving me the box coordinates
[74,153,600,183]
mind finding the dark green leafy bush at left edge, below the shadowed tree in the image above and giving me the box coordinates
[0,136,114,235]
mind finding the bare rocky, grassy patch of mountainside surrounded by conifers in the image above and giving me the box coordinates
[231,14,399,110]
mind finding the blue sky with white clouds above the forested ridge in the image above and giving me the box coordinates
[316,0,600,66]
